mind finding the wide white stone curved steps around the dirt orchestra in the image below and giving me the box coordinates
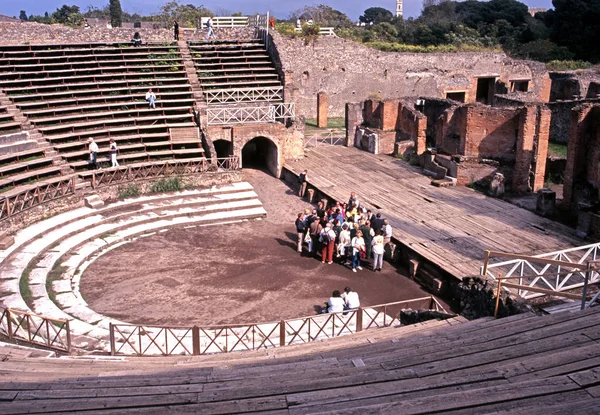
[0,183,266,352]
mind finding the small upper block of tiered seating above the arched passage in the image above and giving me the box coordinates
[189,40,283,104]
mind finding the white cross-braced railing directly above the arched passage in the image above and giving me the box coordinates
[206,103,295,125]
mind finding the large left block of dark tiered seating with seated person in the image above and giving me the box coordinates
[0,43,203,177]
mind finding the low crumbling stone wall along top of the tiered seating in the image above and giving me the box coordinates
[0,22,254,45]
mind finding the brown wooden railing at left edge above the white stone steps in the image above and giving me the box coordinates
[0,177,75,221]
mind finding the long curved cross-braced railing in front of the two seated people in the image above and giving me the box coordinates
[110,297,444,356]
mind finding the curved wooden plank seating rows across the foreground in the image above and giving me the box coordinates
[0,309,600,415]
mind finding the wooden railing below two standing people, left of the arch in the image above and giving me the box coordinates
[82,156,240,189]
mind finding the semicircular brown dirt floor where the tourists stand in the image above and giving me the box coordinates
[81,170,440,326]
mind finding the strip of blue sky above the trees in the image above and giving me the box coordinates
[0,0,552,20]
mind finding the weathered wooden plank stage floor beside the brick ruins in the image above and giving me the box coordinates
[284,146,582,278]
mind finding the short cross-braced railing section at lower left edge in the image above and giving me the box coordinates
[0,308,71,352]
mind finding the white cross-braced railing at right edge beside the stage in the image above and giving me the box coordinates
[480,243,600,299]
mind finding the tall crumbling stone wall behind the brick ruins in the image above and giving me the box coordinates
[272,33,550,117]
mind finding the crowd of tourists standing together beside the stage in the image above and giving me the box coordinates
[295,170,392,272]
